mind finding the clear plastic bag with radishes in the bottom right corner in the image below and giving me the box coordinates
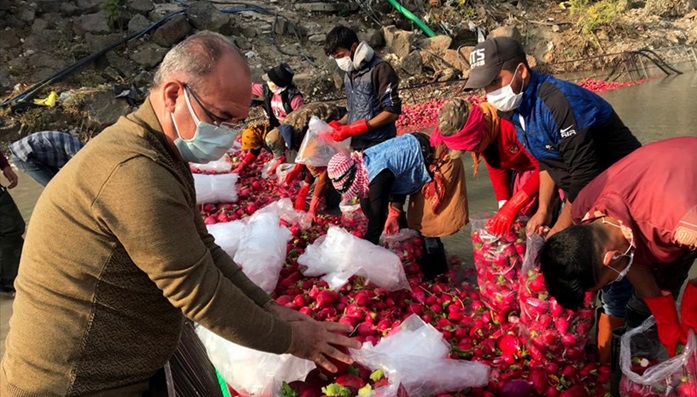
[620,316,697,397]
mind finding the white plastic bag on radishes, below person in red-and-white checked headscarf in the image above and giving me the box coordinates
[298,226,409,291]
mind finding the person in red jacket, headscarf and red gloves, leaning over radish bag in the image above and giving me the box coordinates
[431,98,540,235]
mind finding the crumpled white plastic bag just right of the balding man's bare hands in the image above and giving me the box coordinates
[350,314,489,397]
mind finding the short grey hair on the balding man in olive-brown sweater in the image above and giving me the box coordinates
[153,30,249,91]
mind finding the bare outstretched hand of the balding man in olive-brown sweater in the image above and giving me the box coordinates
[288,320,361,372]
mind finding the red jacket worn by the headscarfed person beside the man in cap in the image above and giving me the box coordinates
[482,119,540,201]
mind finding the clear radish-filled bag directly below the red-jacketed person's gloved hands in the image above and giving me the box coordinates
[472,213,525,321]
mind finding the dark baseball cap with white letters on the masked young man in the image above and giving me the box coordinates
[465,37,525,91]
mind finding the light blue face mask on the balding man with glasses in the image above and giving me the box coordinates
[170,89,239,163]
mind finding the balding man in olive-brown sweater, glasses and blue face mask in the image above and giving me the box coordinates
[0,32,359,397]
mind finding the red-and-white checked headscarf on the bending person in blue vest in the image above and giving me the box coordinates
[327,152,369,199]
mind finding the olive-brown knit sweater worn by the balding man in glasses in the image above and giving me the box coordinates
[0,101,292,397]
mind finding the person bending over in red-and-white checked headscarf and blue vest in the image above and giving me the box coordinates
[327,133,468,278]
